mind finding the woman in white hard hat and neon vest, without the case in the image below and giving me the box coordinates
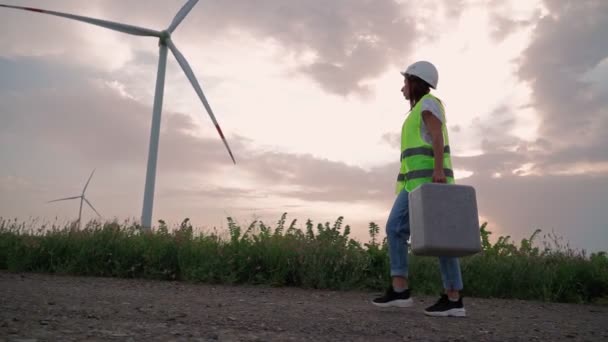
[373,61,466,317]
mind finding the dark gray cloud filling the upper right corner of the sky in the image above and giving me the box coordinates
[519,0,608,161]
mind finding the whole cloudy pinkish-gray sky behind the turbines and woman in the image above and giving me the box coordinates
[0,0,608,250]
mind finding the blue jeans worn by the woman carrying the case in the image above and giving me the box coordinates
[386,190,462,291]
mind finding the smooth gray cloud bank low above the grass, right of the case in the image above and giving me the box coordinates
[459,172,608,251]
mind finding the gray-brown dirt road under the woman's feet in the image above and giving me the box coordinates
[0,272,608,341]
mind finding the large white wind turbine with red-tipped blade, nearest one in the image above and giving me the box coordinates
[0,0,236,229]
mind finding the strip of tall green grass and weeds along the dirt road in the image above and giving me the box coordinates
[0,214,608,303]
